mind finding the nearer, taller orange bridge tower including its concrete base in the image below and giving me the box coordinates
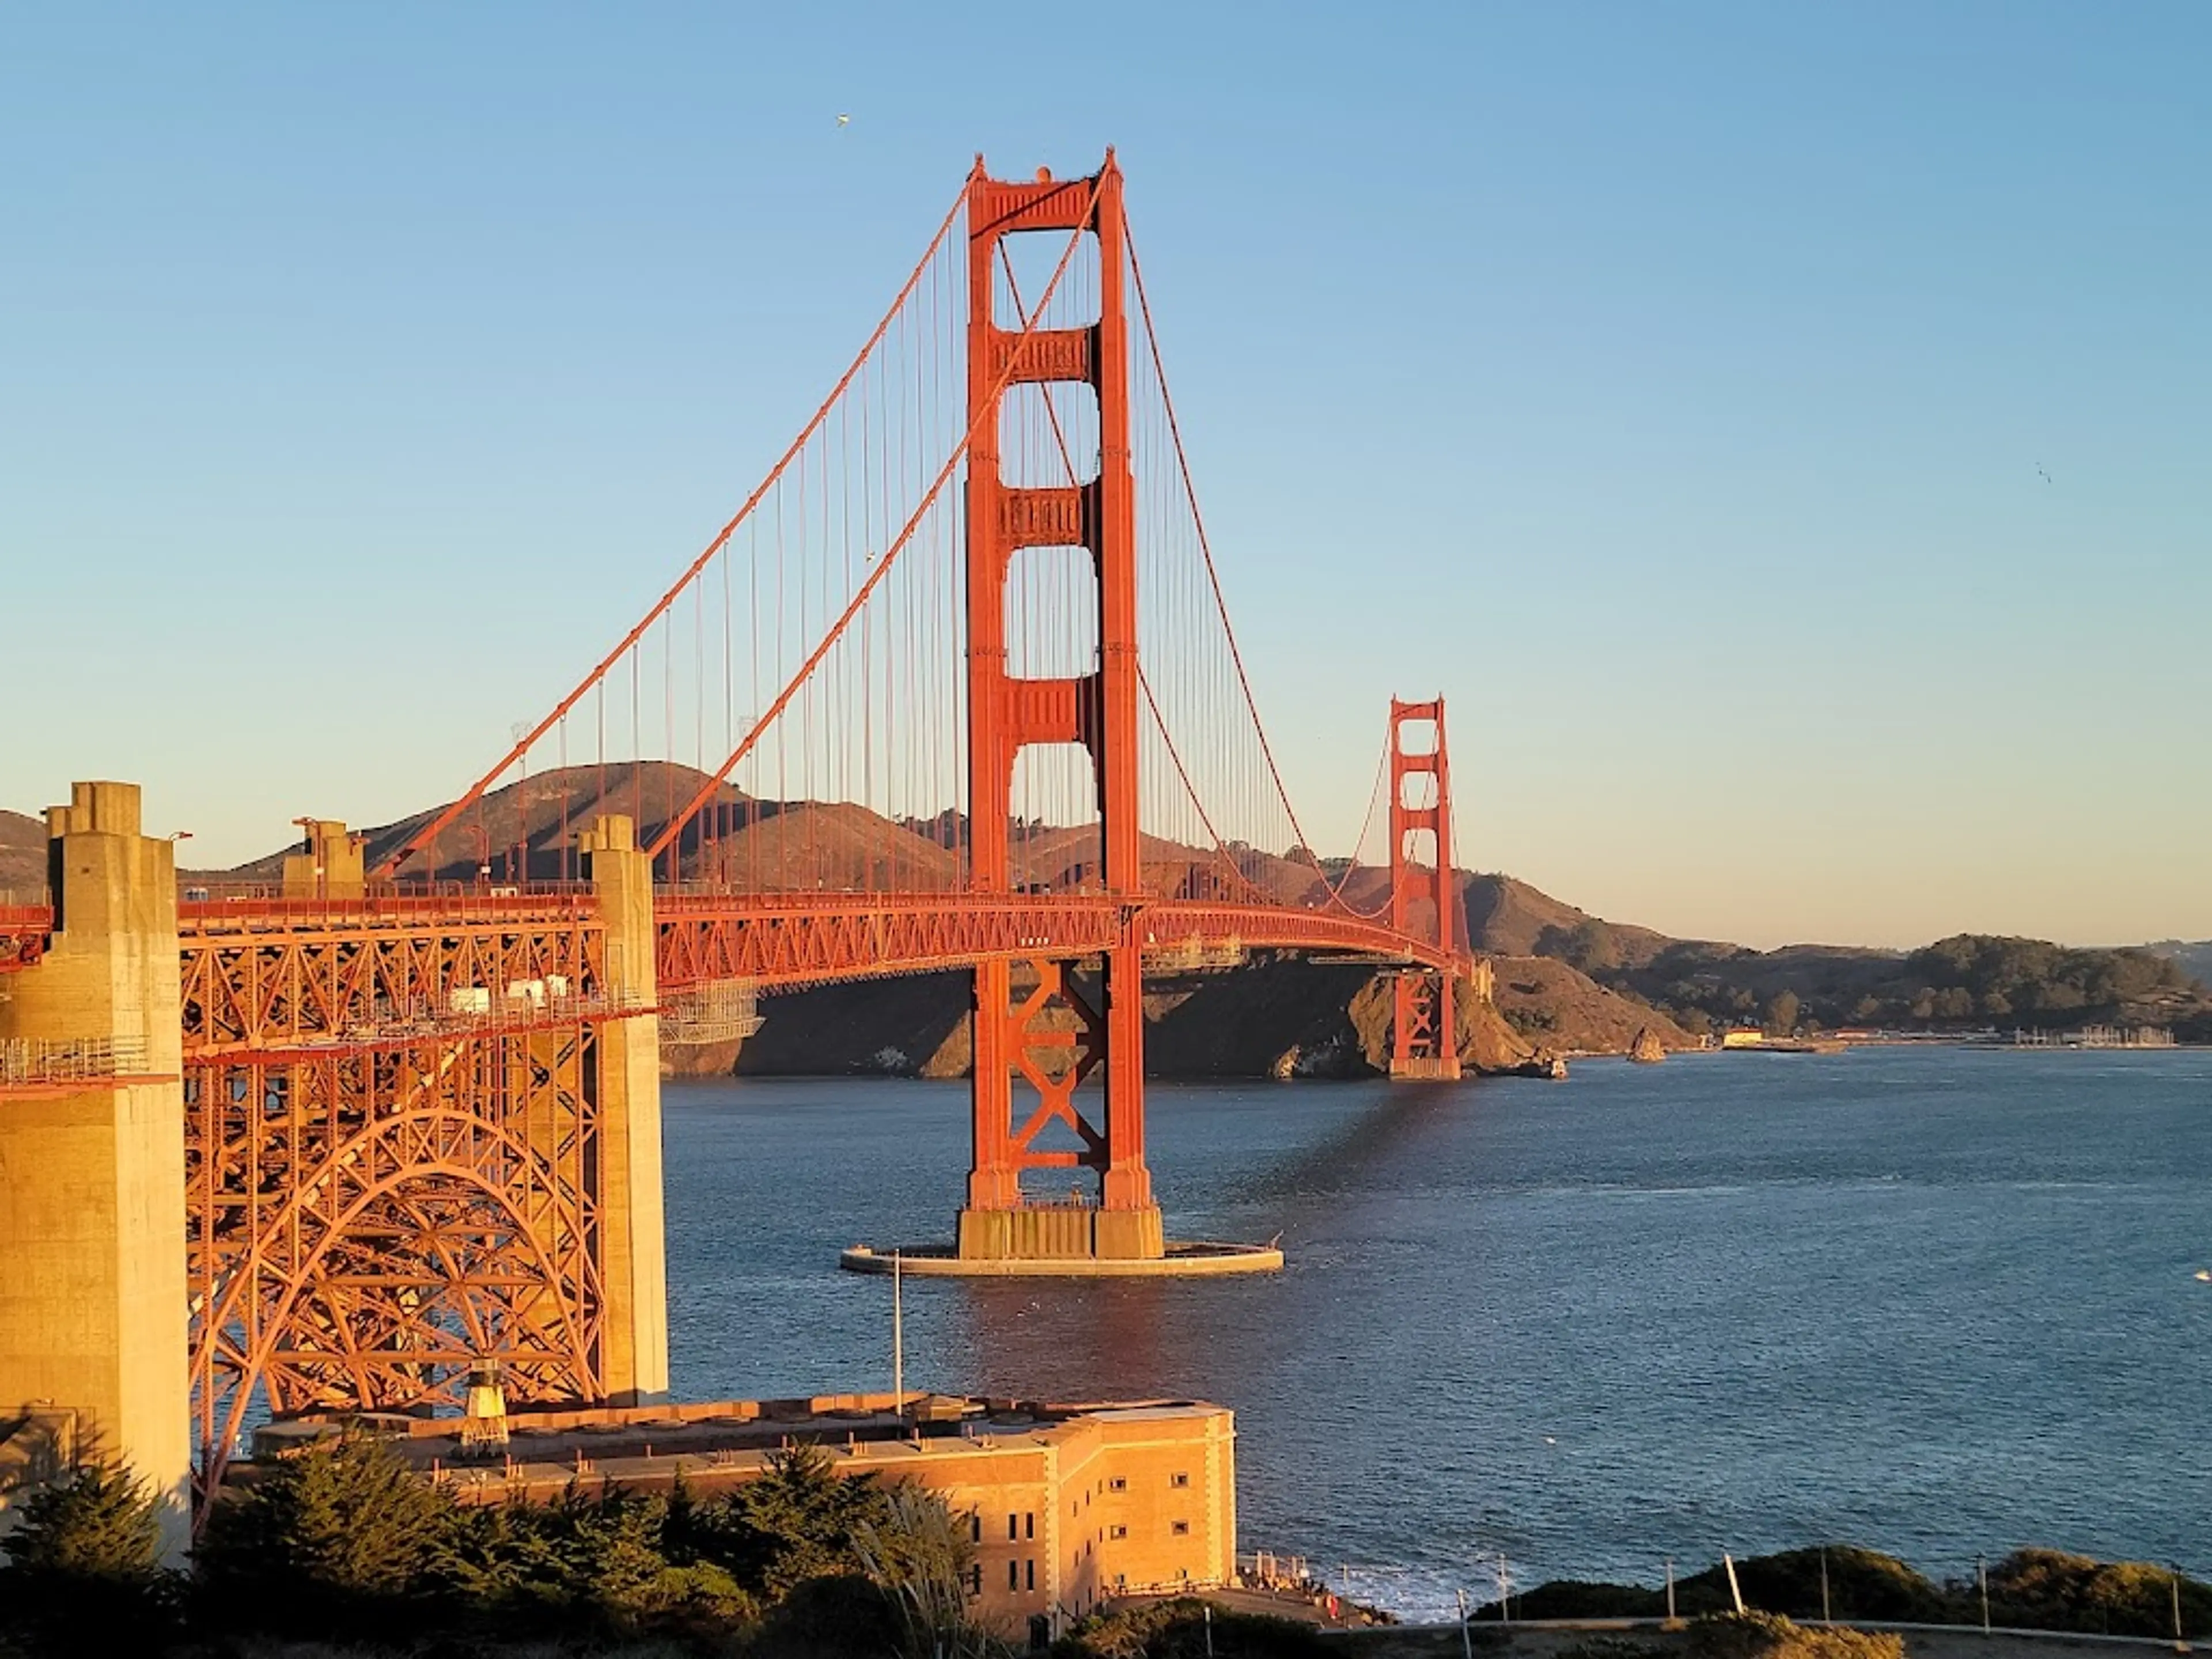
[960,150,1166,1259]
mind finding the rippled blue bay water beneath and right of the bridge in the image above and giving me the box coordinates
[666,1048,2212,1612]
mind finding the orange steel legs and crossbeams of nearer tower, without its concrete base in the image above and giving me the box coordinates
[967,150,1153,1210]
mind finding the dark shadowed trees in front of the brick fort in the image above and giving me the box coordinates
[0,1433,1002,1659]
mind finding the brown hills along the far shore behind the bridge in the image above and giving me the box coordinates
[0,787,2212,1052]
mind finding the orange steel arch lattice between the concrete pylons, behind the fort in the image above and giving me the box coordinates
[179,893,637,1488]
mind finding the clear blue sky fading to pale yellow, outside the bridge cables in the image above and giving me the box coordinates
[0,0,2212,945]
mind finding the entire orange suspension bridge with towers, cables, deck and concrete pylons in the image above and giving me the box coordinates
[0,150,1475,1521]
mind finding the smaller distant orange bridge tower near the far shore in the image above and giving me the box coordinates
[1389,697,1460,1080]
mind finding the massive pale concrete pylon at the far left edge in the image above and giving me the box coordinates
[0,783,192,1562]
